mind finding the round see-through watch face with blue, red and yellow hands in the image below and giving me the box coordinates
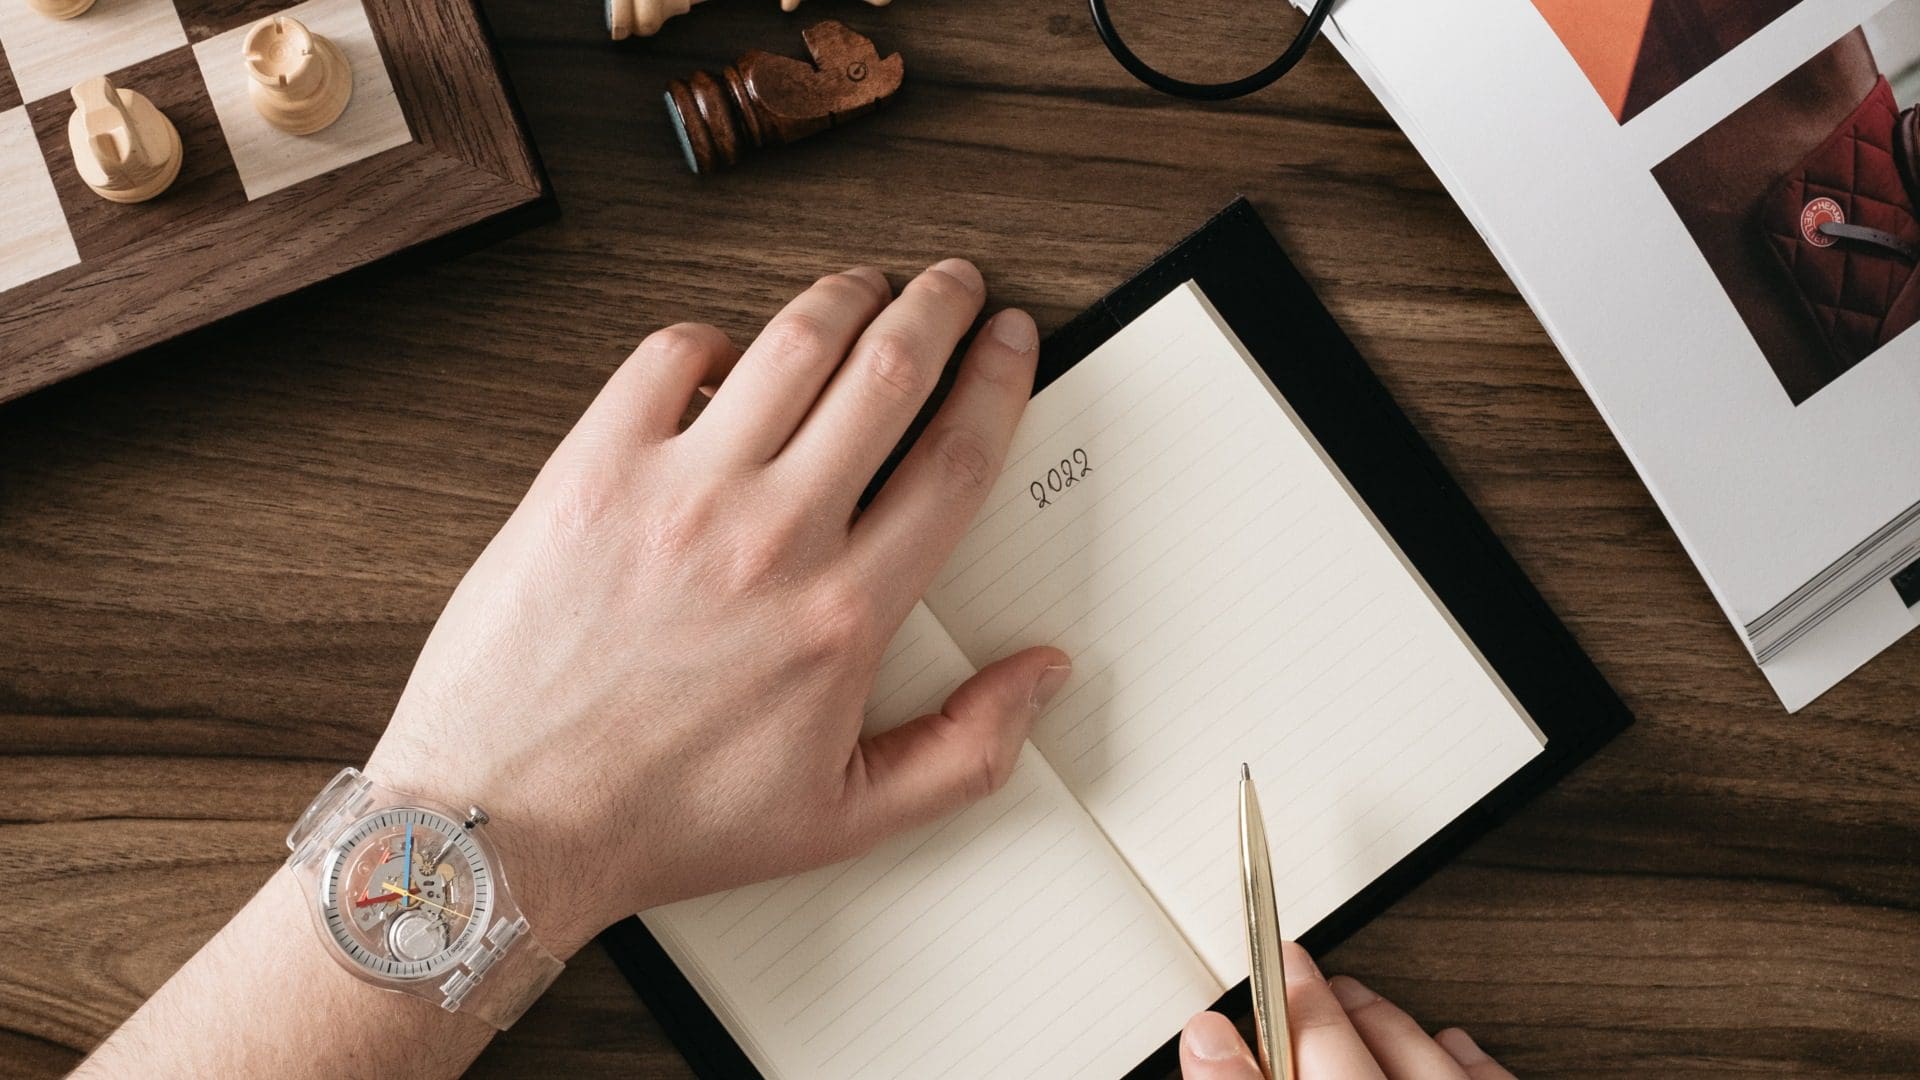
[321,807,493,978]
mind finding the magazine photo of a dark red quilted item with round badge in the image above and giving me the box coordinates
[1653,0,1920,405]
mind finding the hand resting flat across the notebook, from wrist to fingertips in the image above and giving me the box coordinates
[367,259,1068,955]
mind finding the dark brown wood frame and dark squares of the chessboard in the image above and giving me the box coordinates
[0,0,553,402]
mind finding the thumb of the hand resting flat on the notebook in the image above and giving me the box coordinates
[852,648,1073,844]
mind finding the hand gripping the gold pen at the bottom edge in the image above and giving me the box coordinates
[1181,942,1513,1080]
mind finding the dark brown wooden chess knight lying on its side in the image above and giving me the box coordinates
[666,21,906,173]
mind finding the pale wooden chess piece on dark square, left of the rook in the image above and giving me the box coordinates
[67,75,182,202]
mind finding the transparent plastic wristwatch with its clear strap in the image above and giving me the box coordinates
[286,769,564,1028]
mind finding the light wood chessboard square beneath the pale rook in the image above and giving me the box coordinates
[194,0,413,200]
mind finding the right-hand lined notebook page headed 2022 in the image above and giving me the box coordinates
[927,282,1542,984]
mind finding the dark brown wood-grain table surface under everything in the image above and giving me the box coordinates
[0,0,1920,1078]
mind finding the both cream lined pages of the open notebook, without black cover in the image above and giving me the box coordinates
[606,201,1628,1080]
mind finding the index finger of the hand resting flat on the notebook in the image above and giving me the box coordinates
[851,309,1041,619]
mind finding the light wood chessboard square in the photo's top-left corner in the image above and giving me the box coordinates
[0,0,186,102]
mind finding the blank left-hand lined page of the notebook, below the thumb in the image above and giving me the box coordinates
[643,607,1221,1080]
